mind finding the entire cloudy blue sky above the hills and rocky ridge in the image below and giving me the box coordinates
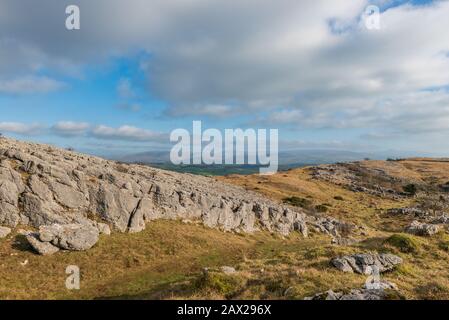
[0,0,449,155]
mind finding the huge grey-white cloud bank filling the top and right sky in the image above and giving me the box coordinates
[0,0,449,140]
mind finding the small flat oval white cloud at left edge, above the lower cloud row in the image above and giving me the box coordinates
[0,76,64,95]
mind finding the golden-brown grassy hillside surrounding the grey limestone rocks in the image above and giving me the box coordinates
[0,159,449,299]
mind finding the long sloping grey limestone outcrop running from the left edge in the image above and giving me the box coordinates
[0,138,358,255]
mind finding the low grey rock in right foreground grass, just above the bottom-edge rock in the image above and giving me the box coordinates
[331,253,402,275]
